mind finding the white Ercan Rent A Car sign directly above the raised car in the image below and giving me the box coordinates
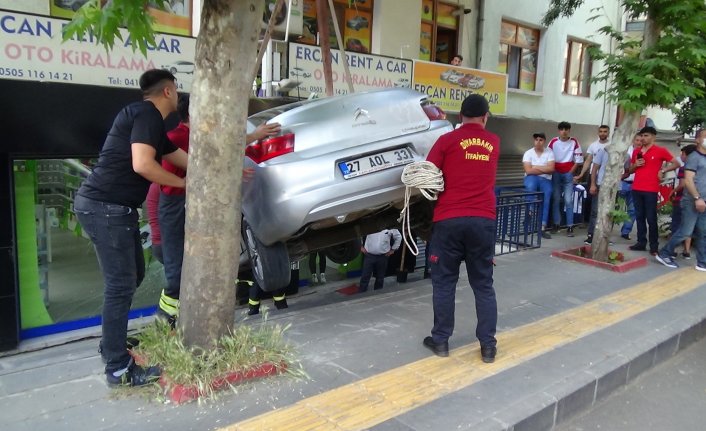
[289,43,412,97]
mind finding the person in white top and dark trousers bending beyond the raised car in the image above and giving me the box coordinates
[358,229,402,293]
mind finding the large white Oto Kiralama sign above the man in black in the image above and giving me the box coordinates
[0,10,196,92]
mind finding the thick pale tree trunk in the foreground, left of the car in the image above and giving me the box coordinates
[179,0,264,348]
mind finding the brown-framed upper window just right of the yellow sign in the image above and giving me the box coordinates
[497,21,539,91]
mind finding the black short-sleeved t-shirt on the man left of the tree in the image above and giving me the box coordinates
[78,101,177,208]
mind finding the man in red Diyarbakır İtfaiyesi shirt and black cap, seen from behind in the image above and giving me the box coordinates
[423,94,500,362]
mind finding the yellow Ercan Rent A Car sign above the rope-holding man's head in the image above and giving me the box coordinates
[412,60,507,114]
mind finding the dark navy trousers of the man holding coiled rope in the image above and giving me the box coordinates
[429,217,498,346]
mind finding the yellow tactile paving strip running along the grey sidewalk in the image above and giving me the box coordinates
[222,268,706,431]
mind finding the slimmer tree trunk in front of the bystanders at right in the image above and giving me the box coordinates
[591,11,661,262]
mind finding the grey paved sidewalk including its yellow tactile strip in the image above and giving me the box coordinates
[0,229,706,431]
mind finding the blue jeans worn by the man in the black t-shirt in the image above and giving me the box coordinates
[74,195,145,373]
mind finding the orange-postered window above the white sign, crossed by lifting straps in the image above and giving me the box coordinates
[297,0,373,54]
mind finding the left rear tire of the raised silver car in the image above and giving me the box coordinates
[243,220,291,292]
